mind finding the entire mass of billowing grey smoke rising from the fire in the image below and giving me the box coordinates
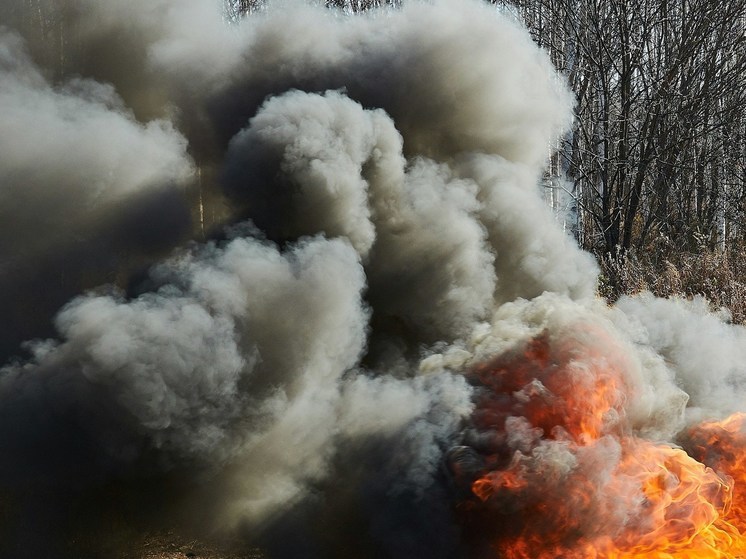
[0,0,746,559]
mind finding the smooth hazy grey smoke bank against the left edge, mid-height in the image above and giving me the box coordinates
[0,30,193,358]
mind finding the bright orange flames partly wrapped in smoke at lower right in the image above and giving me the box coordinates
[461,327,746,559]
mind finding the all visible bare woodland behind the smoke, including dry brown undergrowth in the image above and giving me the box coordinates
[5,0,746,322]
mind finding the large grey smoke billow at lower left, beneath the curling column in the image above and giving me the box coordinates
[0,229,471,556]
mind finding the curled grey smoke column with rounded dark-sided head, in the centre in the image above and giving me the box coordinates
[226,92,495,341]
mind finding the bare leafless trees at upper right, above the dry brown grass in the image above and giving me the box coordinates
[502,0,746,254]
